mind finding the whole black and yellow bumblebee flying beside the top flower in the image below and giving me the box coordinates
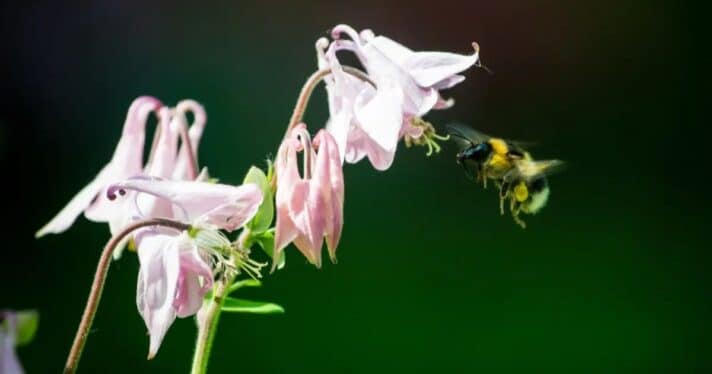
[448,125,563,228]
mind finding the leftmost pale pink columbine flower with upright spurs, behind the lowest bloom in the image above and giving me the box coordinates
[36,96,206,240]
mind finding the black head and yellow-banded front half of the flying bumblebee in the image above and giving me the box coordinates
[448,125,531,188]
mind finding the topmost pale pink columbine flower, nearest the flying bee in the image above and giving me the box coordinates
[316,25,478,170]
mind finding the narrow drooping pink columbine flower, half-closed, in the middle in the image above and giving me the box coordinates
[274,124,344,267]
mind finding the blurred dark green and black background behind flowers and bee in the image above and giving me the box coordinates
[0,0,712,373]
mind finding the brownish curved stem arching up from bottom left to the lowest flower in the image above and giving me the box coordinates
[64,218,190,373]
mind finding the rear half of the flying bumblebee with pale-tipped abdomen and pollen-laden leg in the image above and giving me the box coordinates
[495,159,563,228]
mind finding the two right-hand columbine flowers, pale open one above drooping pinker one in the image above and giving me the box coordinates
[275,25,479,267]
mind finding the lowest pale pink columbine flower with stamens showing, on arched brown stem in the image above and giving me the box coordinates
[107,178,262,358]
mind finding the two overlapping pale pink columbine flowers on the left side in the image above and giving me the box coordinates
[37,97,262,358]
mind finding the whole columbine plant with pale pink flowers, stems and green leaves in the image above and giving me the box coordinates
[37,25,479,371]
